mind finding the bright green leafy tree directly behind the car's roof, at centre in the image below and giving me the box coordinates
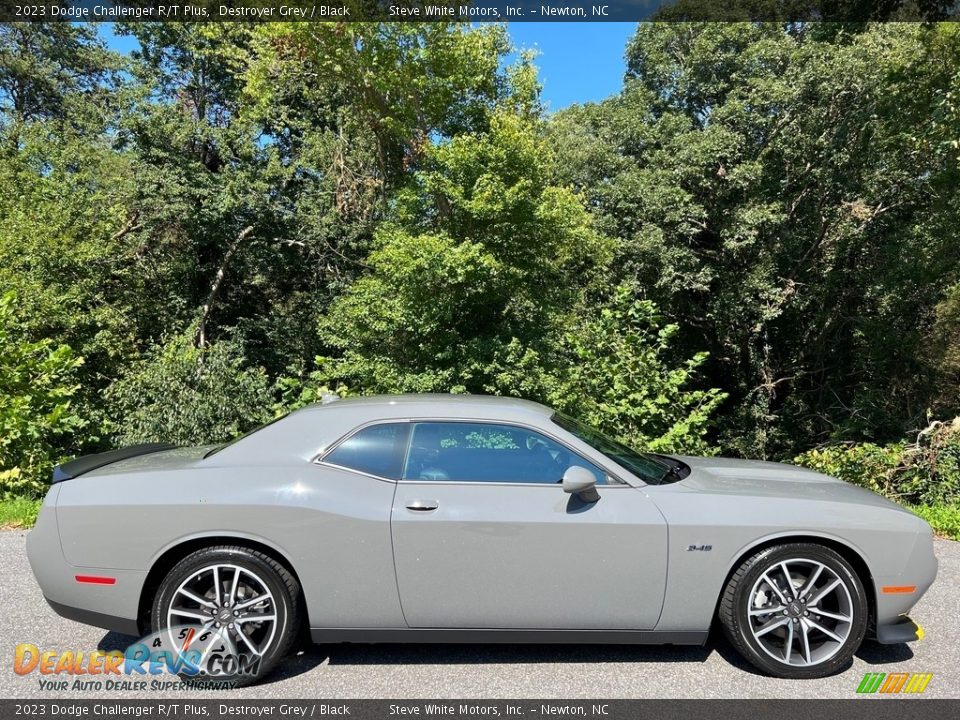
[320,111,609,393]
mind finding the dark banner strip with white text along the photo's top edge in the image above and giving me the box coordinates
[0,0,960,22]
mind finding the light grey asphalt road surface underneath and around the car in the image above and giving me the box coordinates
[0,531,960,699]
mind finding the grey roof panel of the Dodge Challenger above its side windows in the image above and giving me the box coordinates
[301,393,554,417]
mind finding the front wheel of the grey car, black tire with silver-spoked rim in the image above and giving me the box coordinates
[718,543,869,679]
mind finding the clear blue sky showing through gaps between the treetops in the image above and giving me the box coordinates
[101,22,637,111]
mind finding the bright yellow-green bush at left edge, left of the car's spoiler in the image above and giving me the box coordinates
[0,293,84,497]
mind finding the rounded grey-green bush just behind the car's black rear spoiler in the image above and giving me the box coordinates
[106,335,273,445]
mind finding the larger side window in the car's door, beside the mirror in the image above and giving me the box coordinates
[403,422,606,485]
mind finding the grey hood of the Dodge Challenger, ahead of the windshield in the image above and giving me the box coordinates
[675,456,909,512]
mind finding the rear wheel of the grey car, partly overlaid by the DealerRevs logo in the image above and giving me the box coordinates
[152,546,300,686]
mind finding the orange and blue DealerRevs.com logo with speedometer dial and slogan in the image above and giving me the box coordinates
[13,627,261,691]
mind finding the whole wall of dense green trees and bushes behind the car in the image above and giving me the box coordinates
[0,23,960,502]
